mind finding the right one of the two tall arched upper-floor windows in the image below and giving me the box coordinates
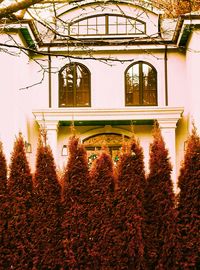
[125,61,157,106]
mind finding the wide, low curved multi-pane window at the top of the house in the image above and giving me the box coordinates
[68,14,146,36]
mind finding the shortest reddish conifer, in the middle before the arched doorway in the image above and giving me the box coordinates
[89,146,117,269]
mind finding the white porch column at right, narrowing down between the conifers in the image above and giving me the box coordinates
[158,119,177,192]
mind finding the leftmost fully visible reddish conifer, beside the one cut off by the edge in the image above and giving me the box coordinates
[7,134,33,269]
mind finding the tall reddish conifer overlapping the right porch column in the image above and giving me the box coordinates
[144,123,177,270]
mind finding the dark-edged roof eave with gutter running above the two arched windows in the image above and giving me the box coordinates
[3,11,200,52]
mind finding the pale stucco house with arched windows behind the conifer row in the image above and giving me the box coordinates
[0,0,200,190]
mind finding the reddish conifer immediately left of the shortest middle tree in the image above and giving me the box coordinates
[62,135,91,269]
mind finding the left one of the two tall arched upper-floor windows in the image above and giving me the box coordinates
[59,63,90,107]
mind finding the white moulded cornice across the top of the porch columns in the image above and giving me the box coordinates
[33,107,183,125]
